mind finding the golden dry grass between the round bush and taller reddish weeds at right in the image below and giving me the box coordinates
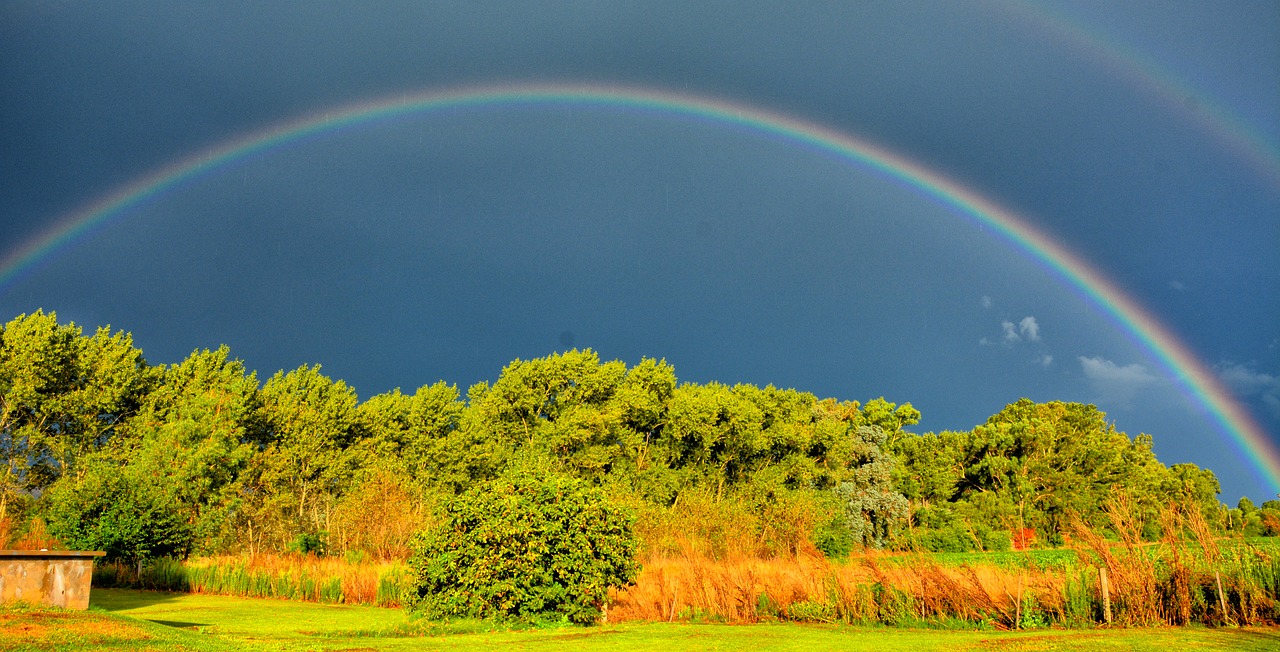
[608,553,1064,626]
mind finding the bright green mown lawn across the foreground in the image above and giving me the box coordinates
[0,589,1280,652]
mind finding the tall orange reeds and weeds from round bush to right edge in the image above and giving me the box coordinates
[609,496,1280,629]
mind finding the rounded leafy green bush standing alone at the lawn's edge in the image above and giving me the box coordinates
[410,471,639,624]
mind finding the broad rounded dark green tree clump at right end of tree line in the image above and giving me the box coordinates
[882,398,1219,546]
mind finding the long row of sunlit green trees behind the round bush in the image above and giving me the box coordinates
[0,311,1280,560]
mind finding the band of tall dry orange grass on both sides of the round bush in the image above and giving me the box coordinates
[82,530,1280,628]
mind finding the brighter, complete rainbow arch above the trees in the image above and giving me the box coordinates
[0,85,1280,489]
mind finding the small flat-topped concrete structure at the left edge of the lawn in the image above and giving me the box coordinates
[0,550,104,611]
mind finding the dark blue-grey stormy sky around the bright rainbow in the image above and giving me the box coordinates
[0,0,1280,503]
